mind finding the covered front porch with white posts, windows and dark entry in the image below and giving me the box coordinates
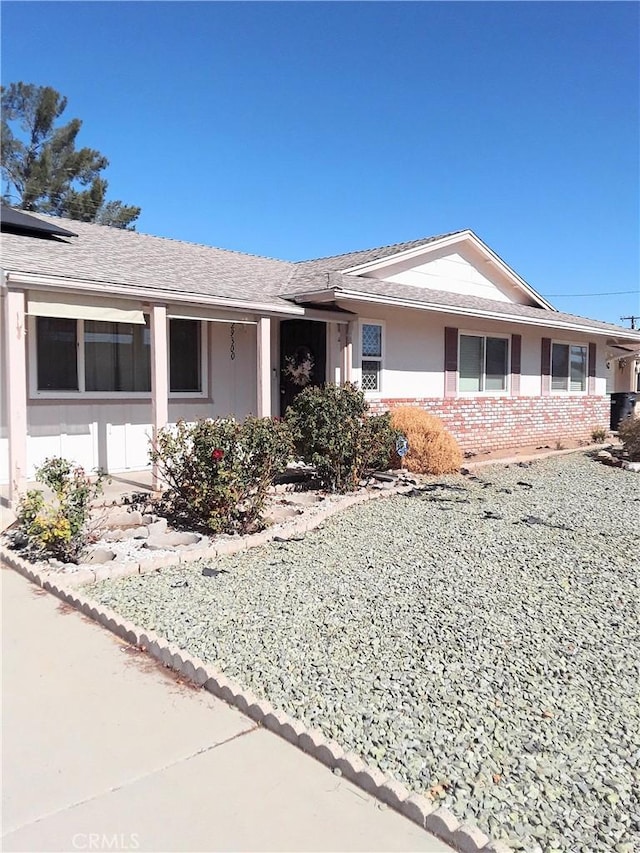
[0,282,354,507]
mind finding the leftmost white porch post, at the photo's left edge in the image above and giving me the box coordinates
[4,290,27,507]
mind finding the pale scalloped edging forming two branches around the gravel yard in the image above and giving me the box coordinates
[0,480,511,853]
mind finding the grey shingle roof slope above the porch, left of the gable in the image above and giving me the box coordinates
[2,214,292,305]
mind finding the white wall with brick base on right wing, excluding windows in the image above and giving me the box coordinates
[354,304,610,451]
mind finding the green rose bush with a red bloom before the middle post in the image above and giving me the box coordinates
[150,418,293,533]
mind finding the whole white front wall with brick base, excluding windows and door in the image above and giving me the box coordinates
[0,290,620,482]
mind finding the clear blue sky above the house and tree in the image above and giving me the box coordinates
[2,0,640,325]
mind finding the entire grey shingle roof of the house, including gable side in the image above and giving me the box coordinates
[2,214,640,340]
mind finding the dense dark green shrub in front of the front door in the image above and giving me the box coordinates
[285,383,397,492]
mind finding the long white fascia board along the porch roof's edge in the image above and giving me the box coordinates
[4,270,304,317]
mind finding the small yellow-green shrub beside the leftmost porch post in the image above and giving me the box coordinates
[17,456,104,563]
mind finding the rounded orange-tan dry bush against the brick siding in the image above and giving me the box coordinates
[391,406,462,474]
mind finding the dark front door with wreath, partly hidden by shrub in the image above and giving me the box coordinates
[280,320,327,415]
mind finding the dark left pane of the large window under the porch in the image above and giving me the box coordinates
[36,317,78,391]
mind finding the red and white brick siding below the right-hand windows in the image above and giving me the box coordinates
[370,396,610,452]
